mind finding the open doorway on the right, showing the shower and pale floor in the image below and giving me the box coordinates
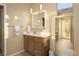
[55,16,73,56]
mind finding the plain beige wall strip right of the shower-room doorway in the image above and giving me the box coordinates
[73,3,79,56]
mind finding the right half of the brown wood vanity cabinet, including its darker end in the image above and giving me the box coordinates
[34,37,49,56]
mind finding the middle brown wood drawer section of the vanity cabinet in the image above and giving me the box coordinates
[34,37,42,56]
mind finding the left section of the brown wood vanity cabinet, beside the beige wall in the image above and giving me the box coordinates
[24,35,33,54]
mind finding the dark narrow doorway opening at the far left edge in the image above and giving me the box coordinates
[0,5,4,56]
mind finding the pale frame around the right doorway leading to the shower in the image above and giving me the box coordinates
[55,14,74,55]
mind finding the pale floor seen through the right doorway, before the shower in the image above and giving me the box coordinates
[56,39,73,56]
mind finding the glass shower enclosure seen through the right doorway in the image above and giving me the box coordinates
[57,17,71,39]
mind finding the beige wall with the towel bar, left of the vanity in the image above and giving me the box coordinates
[5,3,30,55]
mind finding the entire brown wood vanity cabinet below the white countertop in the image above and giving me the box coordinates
[24,35,49,56]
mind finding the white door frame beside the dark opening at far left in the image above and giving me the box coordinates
[0,3,6,56]
